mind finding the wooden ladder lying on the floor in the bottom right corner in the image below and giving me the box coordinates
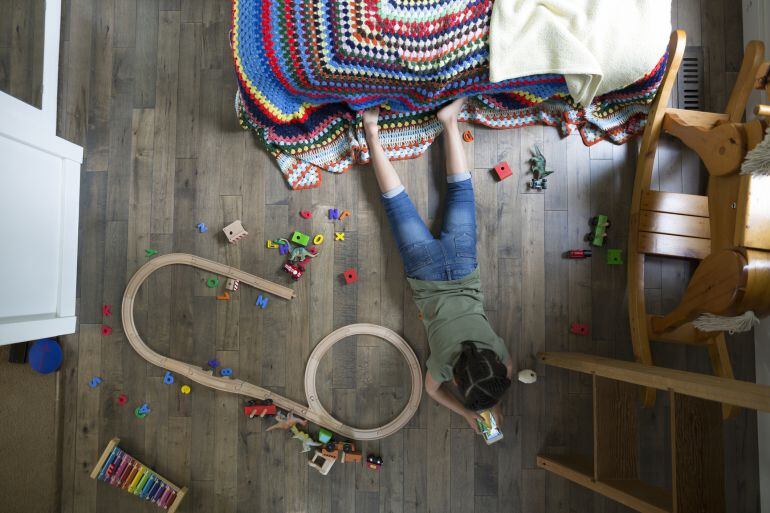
[537,353,770,513]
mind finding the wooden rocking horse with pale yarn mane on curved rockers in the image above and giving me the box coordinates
[628,30,770,418]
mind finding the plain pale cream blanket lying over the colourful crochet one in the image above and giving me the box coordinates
[489,0,671,105]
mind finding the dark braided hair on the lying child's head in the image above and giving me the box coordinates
[454,342,511,411]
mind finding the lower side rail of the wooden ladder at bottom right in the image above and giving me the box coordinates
[537,455,671,513]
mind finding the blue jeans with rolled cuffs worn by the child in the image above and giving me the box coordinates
[382,178,478,281]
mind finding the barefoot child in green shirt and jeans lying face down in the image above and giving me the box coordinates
[363,99,513,433]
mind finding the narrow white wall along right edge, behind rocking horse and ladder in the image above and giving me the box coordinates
[743,0,770,513]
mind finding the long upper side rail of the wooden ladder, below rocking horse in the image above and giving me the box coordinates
[538,353,770,411]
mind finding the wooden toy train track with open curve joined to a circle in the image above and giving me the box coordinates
[121,253,422,440]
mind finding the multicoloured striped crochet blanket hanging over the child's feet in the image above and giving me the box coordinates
[231,0,666,189]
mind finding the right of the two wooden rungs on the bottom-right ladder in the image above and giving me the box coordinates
[671,392,726,513]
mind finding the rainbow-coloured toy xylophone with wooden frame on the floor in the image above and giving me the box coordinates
[91,438,187,513]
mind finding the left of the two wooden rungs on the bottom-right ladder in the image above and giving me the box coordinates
[593,375,639,480]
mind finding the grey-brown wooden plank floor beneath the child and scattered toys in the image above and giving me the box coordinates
[52,0,758,513]
